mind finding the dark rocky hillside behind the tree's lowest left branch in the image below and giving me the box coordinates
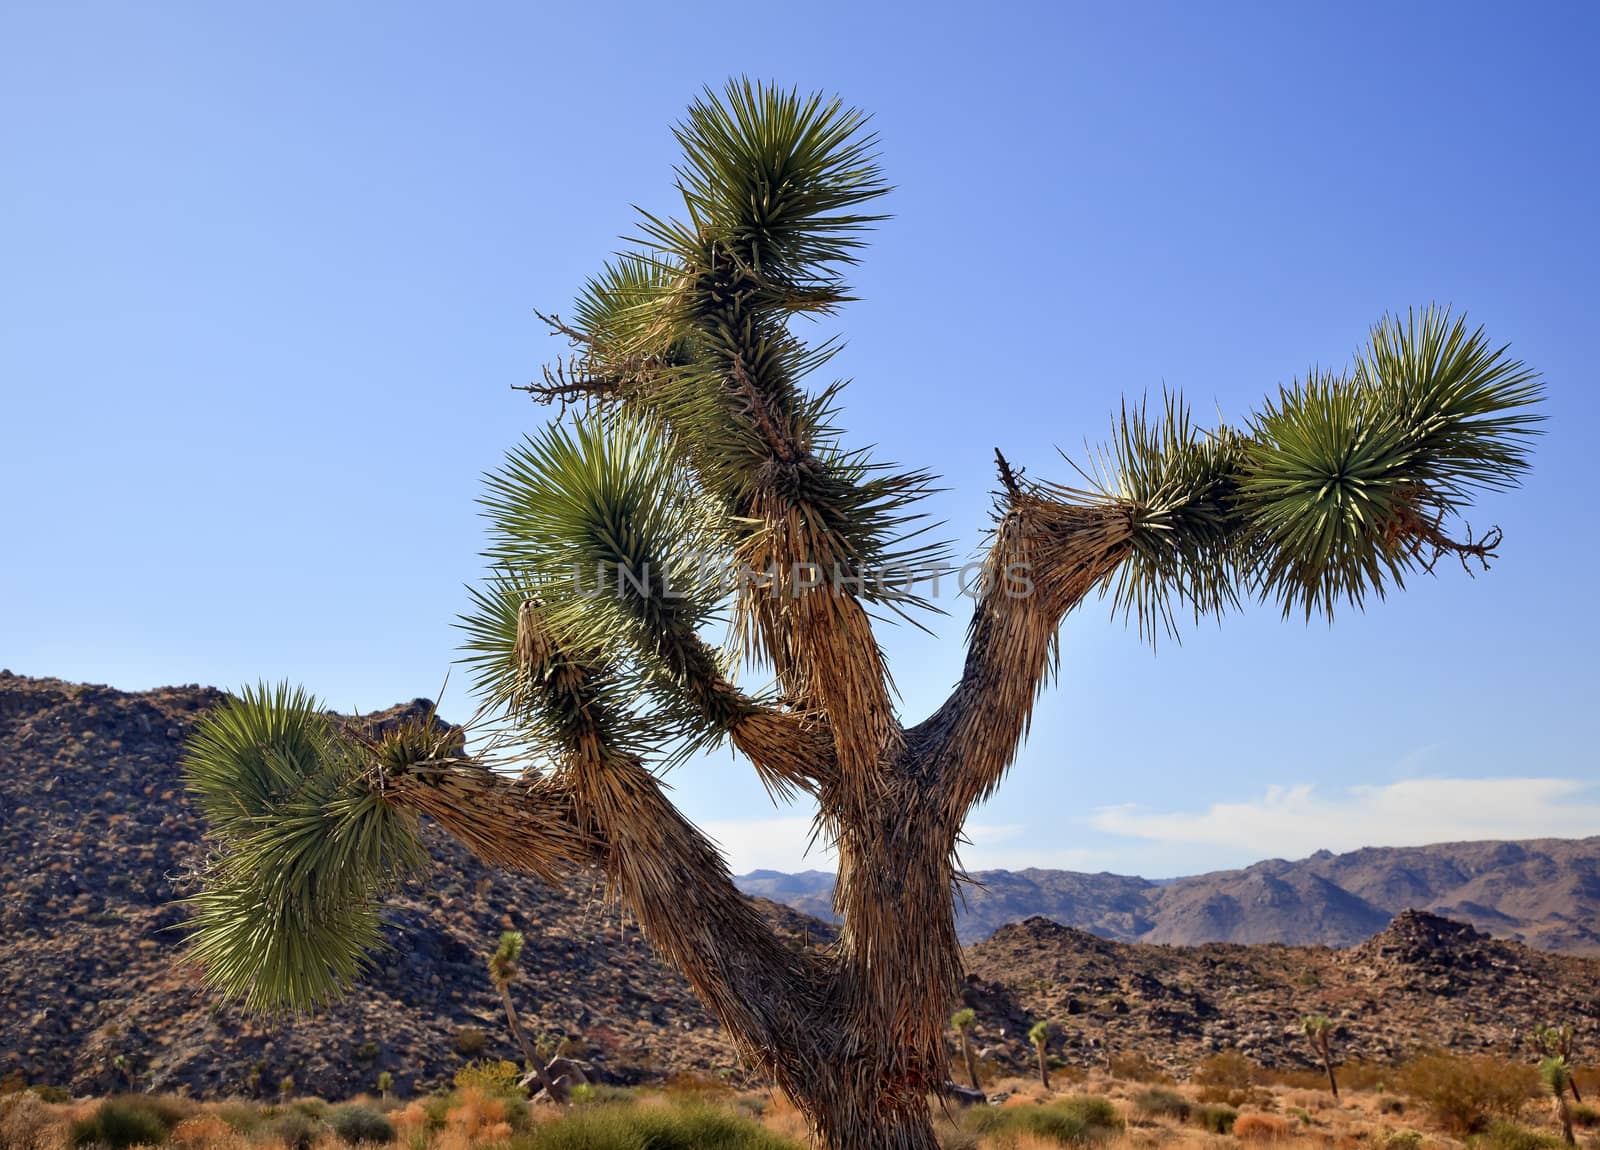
[0,672,829,1097]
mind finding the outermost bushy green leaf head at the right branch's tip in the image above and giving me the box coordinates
[1238,309,1542,619]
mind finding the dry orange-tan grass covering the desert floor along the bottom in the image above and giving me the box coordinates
[0,1060,1600,1150]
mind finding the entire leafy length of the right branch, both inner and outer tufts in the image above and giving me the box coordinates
[1090,307,1542,638]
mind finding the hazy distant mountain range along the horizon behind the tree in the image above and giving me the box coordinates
[738,835,1600,956]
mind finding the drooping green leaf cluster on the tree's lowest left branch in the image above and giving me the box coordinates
[184,685,426,1011]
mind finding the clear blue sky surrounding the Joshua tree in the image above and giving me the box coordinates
[0,2,1600,875]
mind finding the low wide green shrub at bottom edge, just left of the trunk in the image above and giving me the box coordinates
[522,1102,802,1150]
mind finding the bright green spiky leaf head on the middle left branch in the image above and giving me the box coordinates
[469,411,744,764]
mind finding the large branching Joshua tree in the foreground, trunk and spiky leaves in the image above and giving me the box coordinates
[189,83,1541,1150]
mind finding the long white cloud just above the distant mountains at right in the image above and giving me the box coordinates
[1090,777,1600,859]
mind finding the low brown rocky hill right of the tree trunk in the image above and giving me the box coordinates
[963,910,1600,1072]
